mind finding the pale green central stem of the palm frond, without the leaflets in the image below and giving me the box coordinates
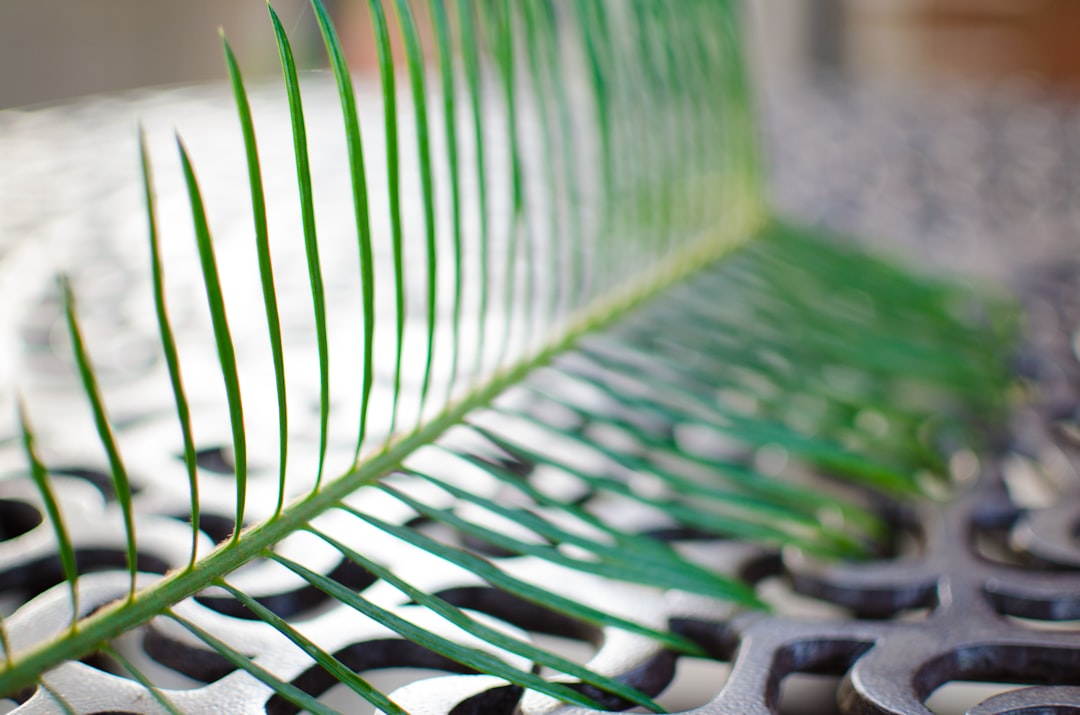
[0,187,769,694]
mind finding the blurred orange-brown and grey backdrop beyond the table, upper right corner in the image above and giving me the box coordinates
[748,0,1080,92]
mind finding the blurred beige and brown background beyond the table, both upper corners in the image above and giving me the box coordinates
[6,0,1080,108]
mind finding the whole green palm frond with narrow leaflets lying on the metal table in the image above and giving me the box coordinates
[0,0,1010,713]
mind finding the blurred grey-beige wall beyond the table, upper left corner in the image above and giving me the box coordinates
[0,0,316,108]
